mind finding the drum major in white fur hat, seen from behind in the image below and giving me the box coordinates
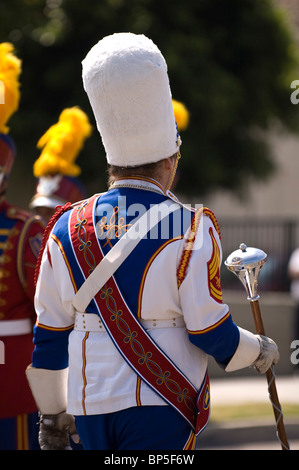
[27,33,278,450]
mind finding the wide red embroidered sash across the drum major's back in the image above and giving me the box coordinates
[70,196,210,435]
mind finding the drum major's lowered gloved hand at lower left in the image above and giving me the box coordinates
[38,411,80,450]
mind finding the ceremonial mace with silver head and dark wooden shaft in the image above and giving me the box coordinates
[224,243,289,450]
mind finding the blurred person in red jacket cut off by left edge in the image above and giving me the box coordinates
[0,43,44,450]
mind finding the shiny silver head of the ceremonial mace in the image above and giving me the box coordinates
[224,243,267,301]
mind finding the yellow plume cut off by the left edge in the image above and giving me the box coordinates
[0,42,22,134]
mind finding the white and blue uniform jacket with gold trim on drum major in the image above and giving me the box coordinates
[32,178,246,415]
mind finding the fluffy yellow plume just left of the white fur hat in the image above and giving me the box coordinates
[33,106,92,178]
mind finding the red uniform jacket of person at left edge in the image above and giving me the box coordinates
[0,200,44,419]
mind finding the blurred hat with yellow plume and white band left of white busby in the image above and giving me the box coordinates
[29,107,92,224]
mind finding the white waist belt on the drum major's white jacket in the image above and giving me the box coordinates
[74,312,185,331]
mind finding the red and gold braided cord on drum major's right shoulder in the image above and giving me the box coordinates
[177,207,221,288]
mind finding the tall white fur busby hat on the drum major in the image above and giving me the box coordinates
[82,33,180,167]
